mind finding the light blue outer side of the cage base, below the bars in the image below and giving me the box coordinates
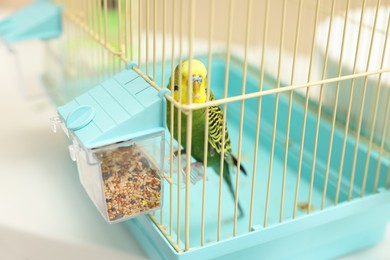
[126,190,390,260]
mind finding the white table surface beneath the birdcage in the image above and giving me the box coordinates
[0,9,390,260]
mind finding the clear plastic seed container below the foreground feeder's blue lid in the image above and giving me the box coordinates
[71,133,164,223]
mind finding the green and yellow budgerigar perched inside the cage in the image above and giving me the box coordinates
[167,60,246,216]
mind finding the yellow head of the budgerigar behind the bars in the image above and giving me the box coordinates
[174,60,207,104]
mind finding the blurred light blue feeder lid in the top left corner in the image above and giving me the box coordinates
[0,0,62,43]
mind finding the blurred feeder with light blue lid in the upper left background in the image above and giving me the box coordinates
[0,0,62,97]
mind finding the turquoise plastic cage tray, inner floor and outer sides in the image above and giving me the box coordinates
[109,57,390,259]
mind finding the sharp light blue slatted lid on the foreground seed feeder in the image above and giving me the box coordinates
[57,65,166,149]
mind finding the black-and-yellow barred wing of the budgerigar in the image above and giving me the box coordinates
[208,93,232,159]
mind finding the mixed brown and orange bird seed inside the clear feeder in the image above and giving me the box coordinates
[97,144,161,221]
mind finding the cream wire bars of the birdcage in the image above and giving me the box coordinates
[49,0,390,258]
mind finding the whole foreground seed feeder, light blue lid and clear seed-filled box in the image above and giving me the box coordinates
[52,66,166,223]
